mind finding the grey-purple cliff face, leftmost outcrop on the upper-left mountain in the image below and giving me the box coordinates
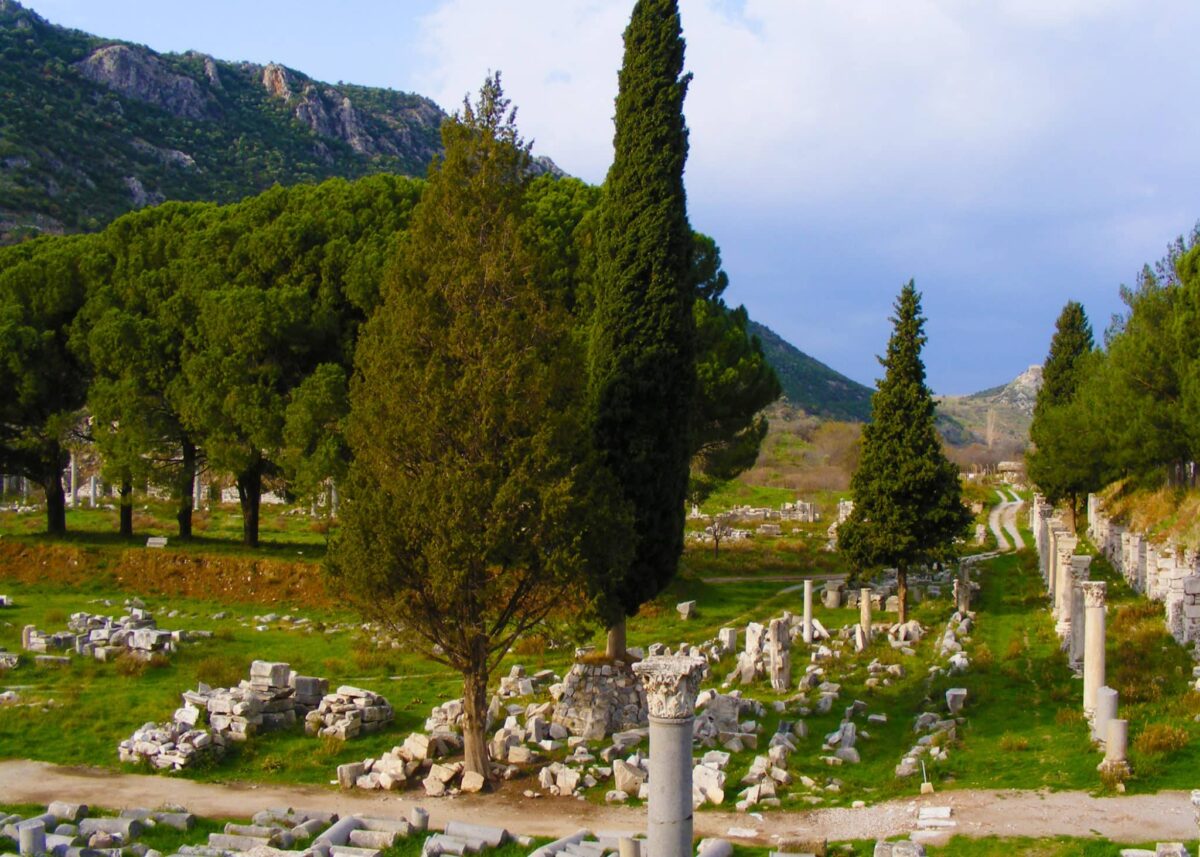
[76,44,221,119]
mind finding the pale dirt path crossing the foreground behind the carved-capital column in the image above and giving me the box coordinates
[0,760,1196,845]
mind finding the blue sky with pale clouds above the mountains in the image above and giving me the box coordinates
[26,0,1200,394]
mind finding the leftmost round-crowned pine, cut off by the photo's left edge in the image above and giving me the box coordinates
[0,236,103,535]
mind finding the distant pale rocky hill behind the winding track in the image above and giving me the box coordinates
[937,366,1042,449]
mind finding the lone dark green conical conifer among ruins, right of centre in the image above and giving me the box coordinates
[838,281,971,622]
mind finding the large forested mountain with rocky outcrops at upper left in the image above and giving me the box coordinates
[0,0,451,242]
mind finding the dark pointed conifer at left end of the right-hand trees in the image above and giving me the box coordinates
[1026,300,1103,527]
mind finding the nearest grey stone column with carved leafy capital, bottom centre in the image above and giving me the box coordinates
[634,655,706,857]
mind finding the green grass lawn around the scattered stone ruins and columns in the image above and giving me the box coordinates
[7,489,1200,806]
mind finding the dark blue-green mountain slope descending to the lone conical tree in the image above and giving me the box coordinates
[750,322,874,421]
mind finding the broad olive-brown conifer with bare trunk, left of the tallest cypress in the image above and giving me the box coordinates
[330,74,630,777]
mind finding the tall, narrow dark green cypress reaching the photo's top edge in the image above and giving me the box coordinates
[589,0,696,654]
